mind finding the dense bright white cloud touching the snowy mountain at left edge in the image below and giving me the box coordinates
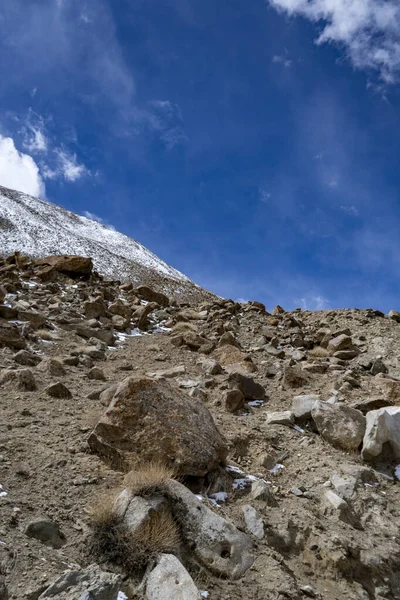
[0,135,45,197]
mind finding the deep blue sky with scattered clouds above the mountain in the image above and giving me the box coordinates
[0,0,400,310]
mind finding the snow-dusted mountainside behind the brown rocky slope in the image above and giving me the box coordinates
[0,186,213,300]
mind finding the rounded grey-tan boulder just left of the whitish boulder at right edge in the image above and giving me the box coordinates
[311,402,366,450]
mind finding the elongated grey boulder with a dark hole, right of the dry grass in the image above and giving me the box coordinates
[167,479,254,579]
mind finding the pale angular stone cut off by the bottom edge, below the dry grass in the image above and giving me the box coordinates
[146,554,200,600]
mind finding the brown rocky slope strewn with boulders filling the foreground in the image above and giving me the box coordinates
[0,256,400,600]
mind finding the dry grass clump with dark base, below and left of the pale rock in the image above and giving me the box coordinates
[89,493,181,573]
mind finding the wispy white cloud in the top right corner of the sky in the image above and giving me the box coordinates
[267,0,400,83]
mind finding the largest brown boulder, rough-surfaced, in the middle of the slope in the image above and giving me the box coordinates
[89,377,227,476]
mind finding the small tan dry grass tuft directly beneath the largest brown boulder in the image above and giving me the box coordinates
[124,462,176,496]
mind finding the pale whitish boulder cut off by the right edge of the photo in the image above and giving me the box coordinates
[362,406,400,460]
